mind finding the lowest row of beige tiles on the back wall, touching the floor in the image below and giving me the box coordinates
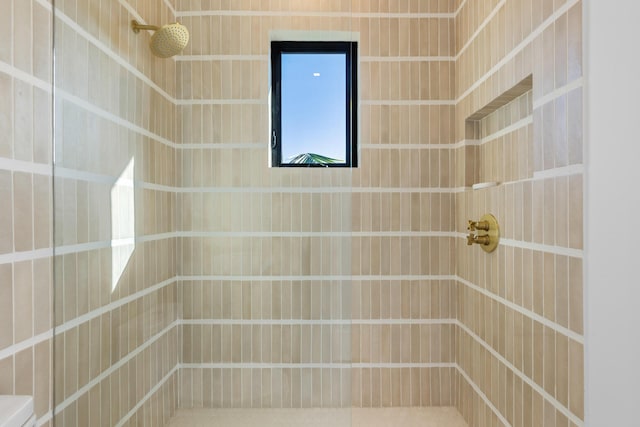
[180,365,457,408]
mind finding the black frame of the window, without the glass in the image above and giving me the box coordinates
[271,41,358,168]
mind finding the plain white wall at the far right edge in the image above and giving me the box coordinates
[584,0,640,427]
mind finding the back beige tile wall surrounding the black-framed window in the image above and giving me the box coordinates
[177,1,457,407]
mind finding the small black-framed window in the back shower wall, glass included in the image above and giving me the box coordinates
[271,41,358,167]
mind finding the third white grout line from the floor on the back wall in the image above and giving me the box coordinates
[176,274,459,286]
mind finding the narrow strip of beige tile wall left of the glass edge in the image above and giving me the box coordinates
[0,0,53,425]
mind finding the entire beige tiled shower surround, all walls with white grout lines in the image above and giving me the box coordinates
[0,0,584,427]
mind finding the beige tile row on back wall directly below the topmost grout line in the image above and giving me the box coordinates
[181,15,454,57]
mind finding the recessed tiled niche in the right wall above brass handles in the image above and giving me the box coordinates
[464,75,533,187]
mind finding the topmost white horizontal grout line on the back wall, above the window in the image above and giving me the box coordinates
[176,10,455,19]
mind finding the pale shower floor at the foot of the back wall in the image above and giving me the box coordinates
[168,407,467,427]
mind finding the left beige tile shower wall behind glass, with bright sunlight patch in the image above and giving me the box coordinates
[53,0,178,426]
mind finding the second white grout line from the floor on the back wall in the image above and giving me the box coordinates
[178,319,458,326]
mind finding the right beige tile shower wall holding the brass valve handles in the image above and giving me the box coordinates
[455,0,584,426]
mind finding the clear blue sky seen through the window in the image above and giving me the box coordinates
[281,53,347,163]
